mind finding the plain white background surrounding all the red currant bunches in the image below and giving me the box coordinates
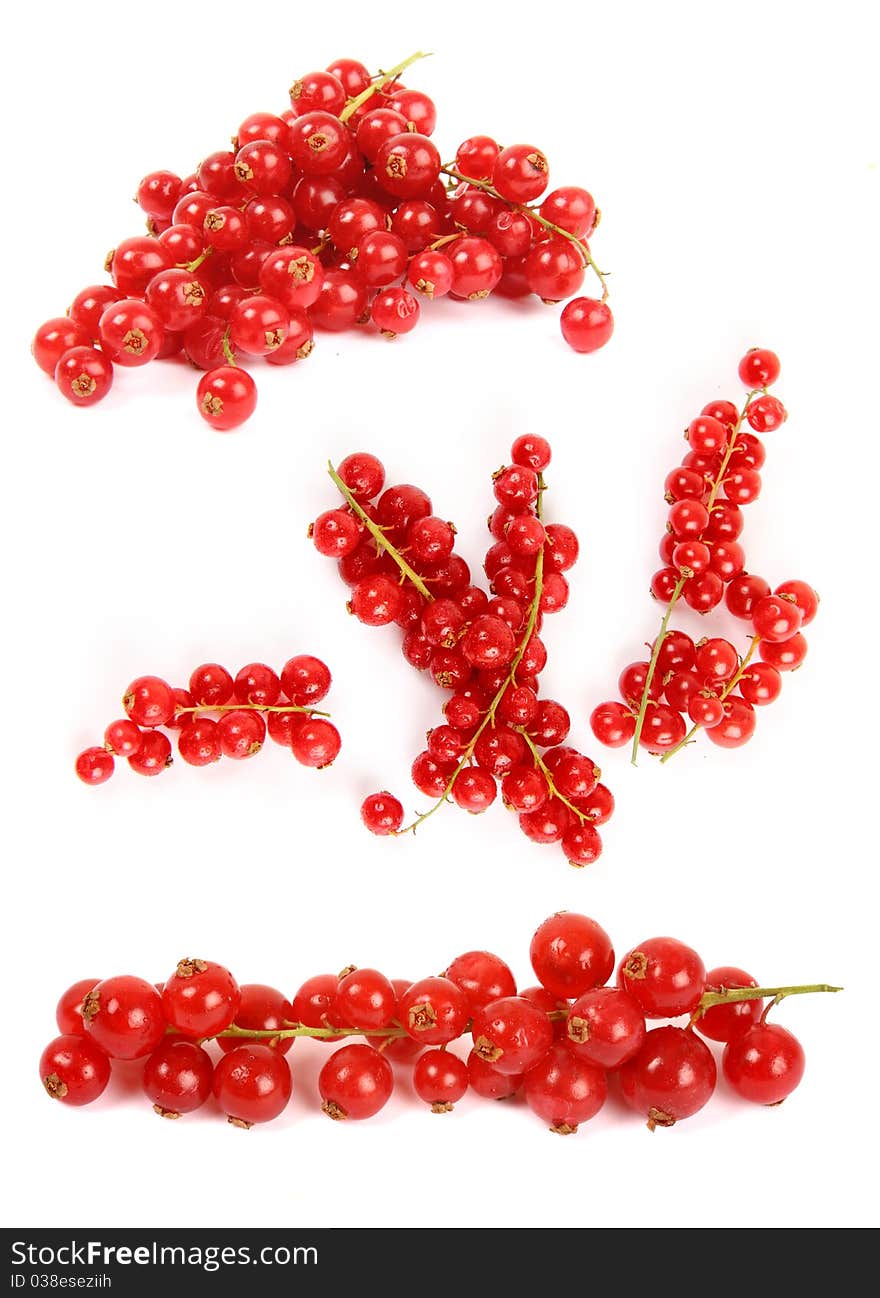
[0,0,880,1227]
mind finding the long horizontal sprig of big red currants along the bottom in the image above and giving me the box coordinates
[40,911,838,1134]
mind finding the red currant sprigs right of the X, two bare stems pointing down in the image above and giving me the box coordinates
[591,348,819,763]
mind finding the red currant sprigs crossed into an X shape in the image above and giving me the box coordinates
[310,436,614,866]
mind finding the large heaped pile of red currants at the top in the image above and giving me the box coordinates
[32,55,613,431]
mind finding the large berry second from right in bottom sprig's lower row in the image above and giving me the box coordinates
[619,1028,718,1131]
